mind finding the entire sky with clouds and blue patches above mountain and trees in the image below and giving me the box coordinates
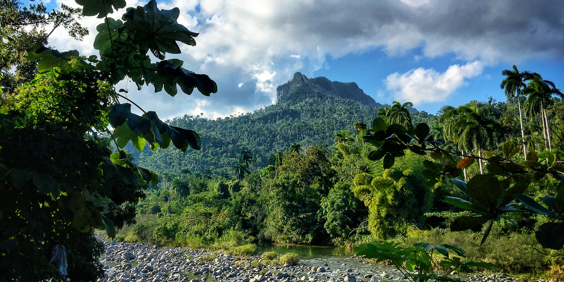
[34,0,564,119]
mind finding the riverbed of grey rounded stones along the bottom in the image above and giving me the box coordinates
[99,241,540,282]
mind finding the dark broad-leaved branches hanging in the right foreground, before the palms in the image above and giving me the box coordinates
[367,106,564,249]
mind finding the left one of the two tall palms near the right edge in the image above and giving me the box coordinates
[500,65,530,160]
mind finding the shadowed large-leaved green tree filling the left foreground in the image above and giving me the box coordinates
[0,1,217,281]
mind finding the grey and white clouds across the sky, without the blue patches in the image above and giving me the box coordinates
[46,0,564,116]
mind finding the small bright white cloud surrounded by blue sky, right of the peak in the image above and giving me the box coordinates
[384,61,483,105]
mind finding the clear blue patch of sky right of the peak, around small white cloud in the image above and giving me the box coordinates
[313,49,564,114]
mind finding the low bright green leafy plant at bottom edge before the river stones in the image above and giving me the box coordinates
[355,241,495,281]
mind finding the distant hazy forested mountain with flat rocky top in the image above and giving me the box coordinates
[127,73,428,175]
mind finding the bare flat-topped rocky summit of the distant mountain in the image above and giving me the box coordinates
[276,72,382,108]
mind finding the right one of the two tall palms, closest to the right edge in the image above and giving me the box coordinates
[523,73,564,150]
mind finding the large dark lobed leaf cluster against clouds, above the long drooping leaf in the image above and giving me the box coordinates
[122,0,198,60]
